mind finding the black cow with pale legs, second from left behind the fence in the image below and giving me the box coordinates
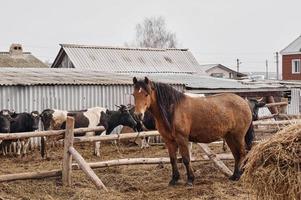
[10,111,40,155]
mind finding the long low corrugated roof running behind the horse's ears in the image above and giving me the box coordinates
[0,68,285,89]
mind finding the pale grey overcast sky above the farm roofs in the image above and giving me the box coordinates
[0,0,301,71]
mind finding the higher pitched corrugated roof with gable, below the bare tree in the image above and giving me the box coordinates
[52,44,206,73]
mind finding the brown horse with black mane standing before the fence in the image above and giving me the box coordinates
[133,77,253,186]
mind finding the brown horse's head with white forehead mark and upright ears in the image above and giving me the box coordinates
[133,77,153,120]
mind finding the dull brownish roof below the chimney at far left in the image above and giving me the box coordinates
[0,52,48,68]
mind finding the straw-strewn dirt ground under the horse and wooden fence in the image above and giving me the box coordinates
[0,143,255,200]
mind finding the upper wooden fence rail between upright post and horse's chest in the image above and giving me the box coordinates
[74,131,160,143]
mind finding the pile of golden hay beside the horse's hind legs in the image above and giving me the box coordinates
[242,123,301,200]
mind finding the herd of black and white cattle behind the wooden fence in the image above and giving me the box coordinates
[0,99,265,157]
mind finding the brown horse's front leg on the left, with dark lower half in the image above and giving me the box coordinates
[166,140,180,186]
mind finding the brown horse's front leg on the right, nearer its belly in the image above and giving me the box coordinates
[176,134,194,186]
